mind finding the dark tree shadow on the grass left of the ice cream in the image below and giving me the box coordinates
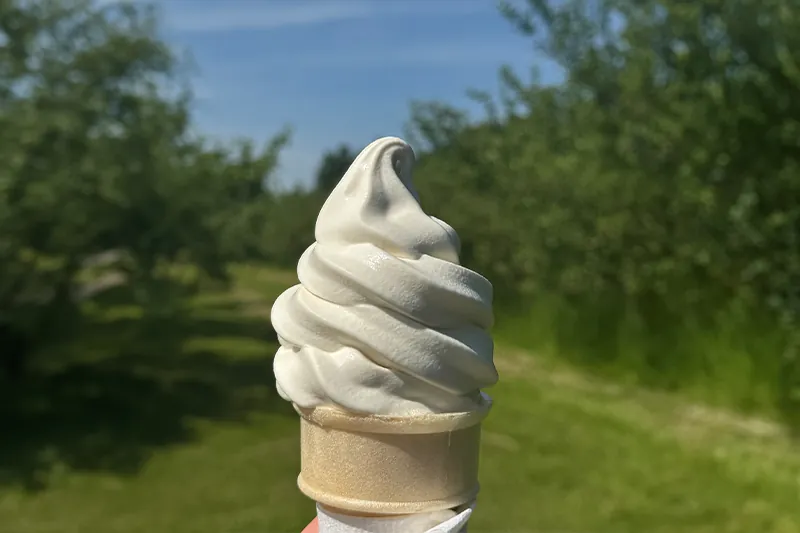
[0,274,294,491]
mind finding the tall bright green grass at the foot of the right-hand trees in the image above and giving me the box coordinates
[496,295,800,420]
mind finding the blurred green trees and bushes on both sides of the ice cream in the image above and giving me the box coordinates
[0,0,800,424]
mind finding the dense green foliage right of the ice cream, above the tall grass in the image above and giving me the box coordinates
[412,0,800,424]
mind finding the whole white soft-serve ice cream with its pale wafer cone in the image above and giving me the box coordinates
[271,137,498,533]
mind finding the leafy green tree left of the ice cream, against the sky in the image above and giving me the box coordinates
[0,0,288,376]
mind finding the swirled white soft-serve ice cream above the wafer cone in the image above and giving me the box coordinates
[272,137,497,416]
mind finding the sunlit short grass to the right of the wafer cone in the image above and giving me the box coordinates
[474,350,800,533]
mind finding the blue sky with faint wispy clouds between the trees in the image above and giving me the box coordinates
[152,0,557,184]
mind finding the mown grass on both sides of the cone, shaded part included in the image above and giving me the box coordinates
[0,268,800,533]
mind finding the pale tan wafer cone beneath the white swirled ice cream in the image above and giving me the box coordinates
[295,395,491,516]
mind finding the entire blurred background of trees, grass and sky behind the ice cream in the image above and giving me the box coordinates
[0,0,800,533]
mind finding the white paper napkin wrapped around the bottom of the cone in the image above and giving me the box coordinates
[317,502,475,533]
